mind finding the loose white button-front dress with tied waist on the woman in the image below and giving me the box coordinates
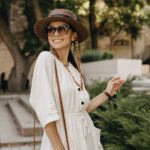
[29,51,103,150]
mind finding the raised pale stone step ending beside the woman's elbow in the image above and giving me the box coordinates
[8,99,43,136]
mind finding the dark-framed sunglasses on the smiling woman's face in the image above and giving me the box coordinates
[45,24,71,36]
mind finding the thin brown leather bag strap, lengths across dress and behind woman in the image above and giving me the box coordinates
[33,59,70,150]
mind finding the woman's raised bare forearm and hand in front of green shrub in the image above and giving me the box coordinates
[86,77,125,113]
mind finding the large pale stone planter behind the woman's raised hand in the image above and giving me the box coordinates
[81,59,142,84]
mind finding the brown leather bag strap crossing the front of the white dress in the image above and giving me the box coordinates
[54,59,69,150]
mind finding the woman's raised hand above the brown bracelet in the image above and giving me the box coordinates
[105,77,125,96]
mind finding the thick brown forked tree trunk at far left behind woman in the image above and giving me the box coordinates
[0,0,43,92]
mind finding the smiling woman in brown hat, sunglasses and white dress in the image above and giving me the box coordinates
[29,9,124,150]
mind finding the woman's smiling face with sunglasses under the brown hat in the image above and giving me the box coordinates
[48,22,77,50]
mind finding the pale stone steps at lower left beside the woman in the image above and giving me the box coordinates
[0,95,43,150]
